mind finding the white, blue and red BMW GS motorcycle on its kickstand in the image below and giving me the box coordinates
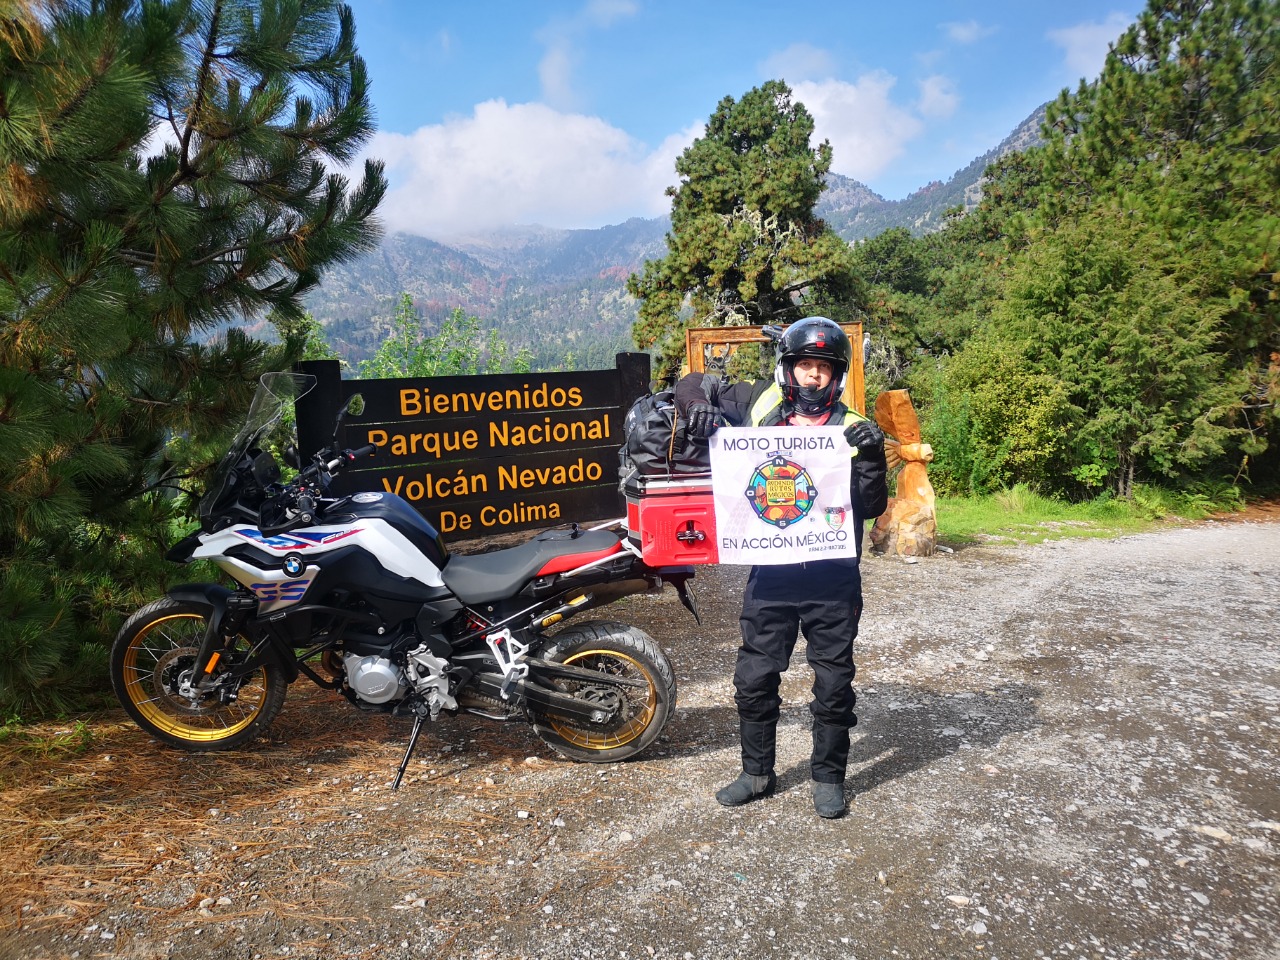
[110,374,698,790]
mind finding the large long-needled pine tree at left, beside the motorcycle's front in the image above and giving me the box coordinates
[0,0,385,707]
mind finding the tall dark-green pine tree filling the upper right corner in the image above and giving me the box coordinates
[1037,0,1280,463]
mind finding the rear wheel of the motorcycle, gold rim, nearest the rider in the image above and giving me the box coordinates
[531,621,676,763]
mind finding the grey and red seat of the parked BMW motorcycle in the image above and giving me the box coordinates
[440,530,622,604]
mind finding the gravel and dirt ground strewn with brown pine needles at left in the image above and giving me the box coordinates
[0,511,1280,960]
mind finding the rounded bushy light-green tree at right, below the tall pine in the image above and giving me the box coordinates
[987,212,1248,497]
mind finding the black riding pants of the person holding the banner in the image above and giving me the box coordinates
[733,558,863,728]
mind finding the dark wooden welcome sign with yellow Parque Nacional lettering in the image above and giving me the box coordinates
[297,353,650,539]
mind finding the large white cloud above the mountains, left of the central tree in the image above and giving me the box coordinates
[366,100,701,238]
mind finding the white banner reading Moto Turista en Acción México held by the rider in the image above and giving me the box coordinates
[710,426,858,564]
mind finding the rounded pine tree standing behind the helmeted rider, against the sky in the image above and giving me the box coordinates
[627,81,859,372]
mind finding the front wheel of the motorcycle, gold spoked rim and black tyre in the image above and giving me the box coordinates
[111,596,288,751]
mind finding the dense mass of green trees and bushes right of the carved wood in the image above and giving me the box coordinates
[856,0,1280,502]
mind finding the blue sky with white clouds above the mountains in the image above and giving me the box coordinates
[348,0,1147,239]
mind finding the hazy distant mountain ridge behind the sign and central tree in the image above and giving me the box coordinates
[303,105,1046,369]
